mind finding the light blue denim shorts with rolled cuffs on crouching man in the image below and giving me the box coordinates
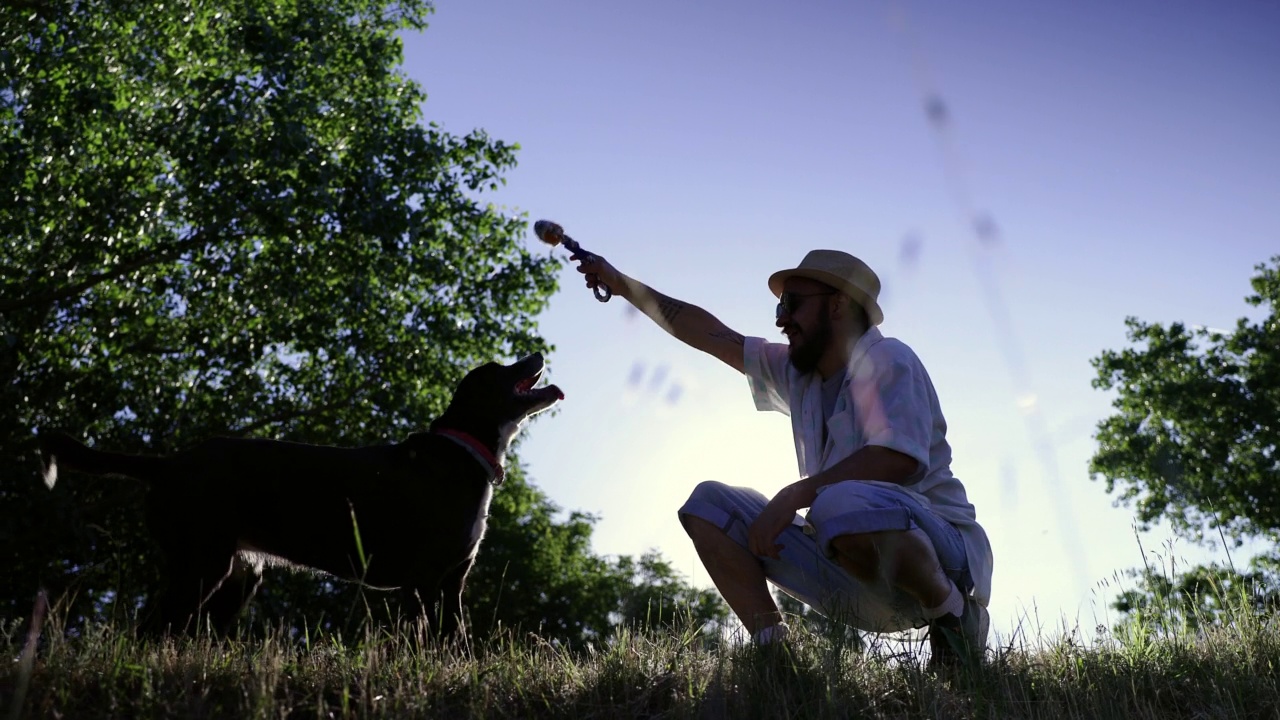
[680,480,973,632]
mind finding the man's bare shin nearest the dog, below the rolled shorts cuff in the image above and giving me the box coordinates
[685,515,782,637]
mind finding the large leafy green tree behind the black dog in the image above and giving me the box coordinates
[0,0,732,633]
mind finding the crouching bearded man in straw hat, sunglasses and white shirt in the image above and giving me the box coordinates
[572,250,992,665]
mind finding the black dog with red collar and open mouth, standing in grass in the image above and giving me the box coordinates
[40,354,564,637]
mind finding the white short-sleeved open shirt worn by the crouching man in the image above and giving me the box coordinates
[744,328,993,605]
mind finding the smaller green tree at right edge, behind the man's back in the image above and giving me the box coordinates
[1089,256,1280,625]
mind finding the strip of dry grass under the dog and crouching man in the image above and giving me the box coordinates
[0,591,1280,719]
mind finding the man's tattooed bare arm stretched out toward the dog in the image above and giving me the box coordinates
[572,255,744,373]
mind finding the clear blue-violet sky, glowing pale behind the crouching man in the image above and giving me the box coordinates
[403,0,1280,644]
